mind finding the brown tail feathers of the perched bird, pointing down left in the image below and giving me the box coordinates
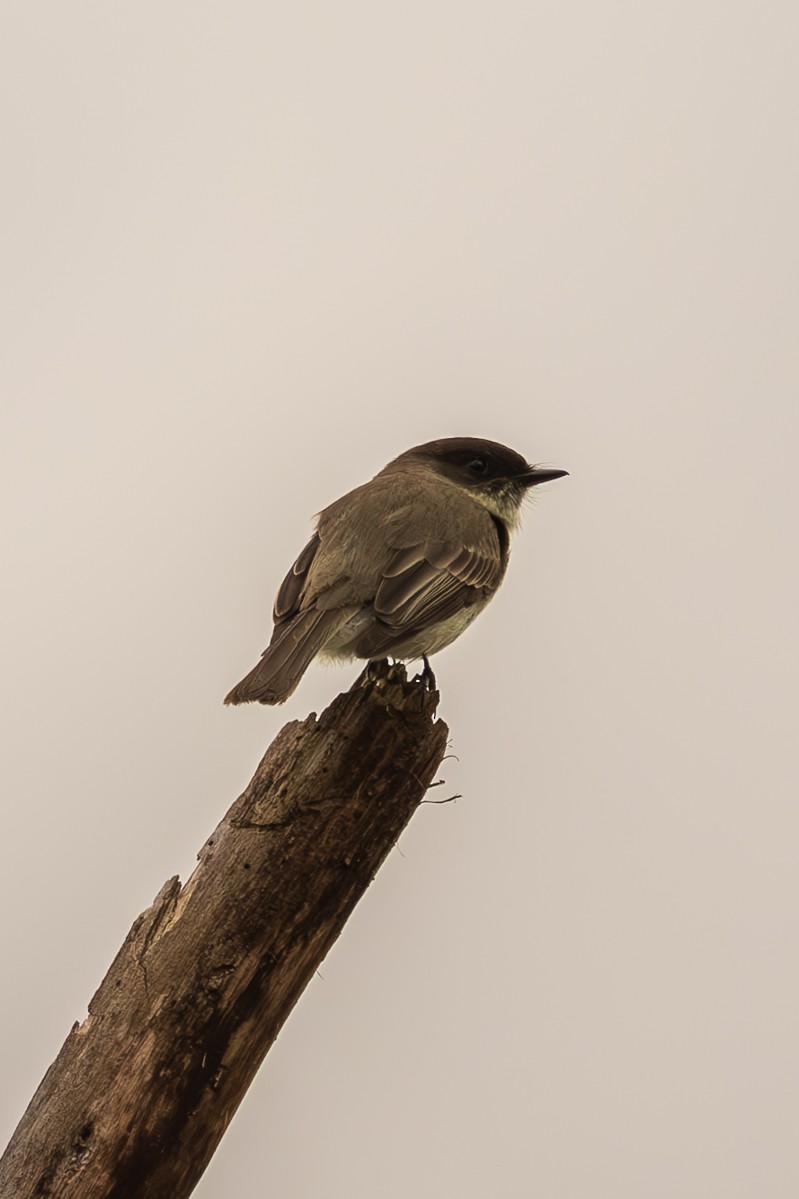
[224,608,349,704]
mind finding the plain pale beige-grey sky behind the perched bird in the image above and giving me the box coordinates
[0,0,799,1199]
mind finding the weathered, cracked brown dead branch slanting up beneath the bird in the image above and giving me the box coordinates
[0,667,447,1199]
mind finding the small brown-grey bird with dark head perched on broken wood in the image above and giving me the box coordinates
[224,438,569,704]
